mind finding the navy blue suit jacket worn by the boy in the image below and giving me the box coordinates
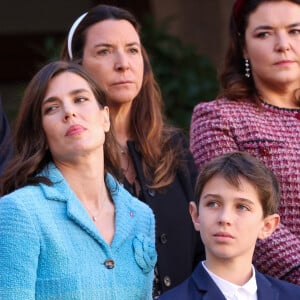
[159,263,300,300]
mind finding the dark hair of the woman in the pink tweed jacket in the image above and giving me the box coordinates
[219,0,300,103]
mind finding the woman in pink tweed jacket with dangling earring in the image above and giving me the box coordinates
[190,0,300,285]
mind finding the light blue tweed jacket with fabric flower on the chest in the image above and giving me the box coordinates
[0,164,156,300]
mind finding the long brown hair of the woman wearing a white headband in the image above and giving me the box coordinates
[61,5,180,188]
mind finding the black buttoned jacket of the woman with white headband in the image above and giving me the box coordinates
[125,135,204,292]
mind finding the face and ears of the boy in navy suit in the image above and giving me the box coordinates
[190,175,279,262]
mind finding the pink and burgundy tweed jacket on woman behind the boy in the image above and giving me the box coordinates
[190,99,300,285]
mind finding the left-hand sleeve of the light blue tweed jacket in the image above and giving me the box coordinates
[0,195,40,300]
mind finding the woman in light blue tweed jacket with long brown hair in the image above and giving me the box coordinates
[0,61,156,300]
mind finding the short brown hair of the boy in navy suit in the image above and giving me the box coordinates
[195,152,280,217]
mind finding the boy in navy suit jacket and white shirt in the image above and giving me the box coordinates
[159,152,300,300]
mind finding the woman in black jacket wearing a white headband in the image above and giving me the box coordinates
[62,5,204,297]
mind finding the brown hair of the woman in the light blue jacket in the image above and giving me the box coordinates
[0,61,117,195]
